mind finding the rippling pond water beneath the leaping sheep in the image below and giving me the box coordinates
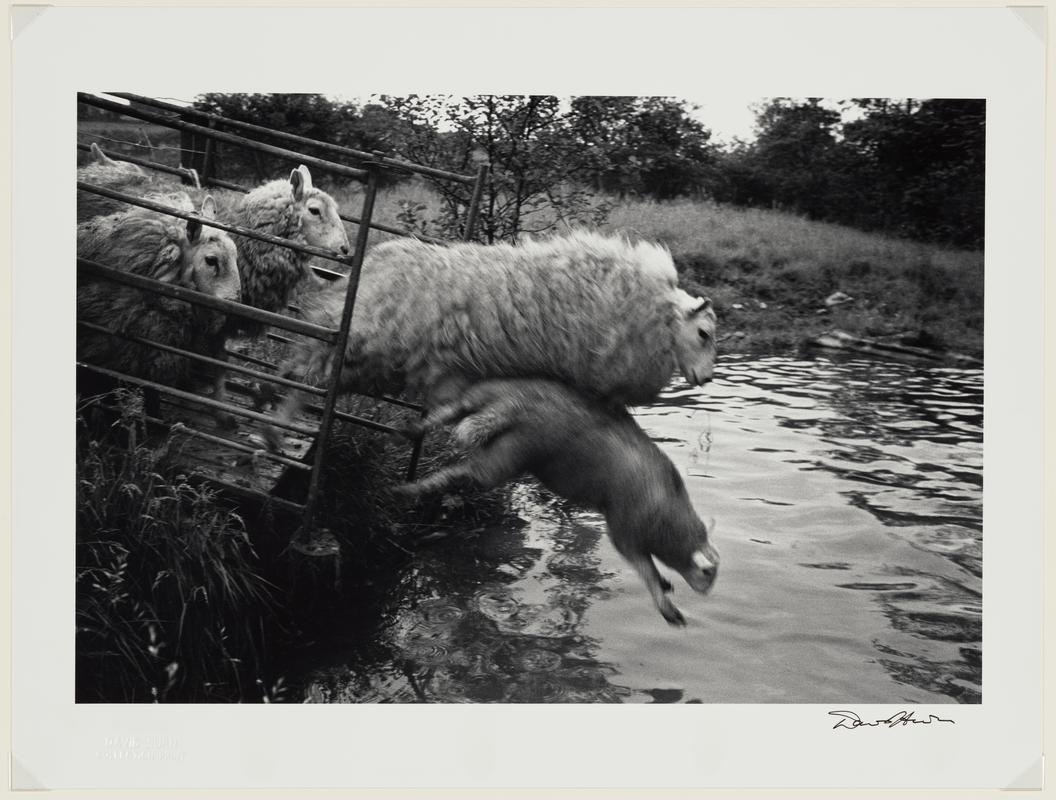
[297,356,983,703]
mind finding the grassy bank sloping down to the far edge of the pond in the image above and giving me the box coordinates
[606,201,983,355]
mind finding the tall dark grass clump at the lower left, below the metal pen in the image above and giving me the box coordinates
[76,391,282,702]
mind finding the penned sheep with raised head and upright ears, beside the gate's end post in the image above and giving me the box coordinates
[221,165,348,332]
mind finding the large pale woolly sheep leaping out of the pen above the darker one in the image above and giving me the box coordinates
[272,231,716,444]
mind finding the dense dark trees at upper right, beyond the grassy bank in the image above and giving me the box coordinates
[715,98,985,248]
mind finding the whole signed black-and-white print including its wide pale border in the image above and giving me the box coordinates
[13,8,1043,788]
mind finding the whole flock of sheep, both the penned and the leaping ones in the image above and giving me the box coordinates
[77,146,718,625]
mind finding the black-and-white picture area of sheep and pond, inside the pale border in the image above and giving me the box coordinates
[77,93,986,719]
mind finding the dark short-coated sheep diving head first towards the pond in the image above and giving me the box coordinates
[403,379,719,625]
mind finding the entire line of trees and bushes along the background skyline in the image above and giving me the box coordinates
[179,94,985,248]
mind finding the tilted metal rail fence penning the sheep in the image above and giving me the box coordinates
[77,93,487,527]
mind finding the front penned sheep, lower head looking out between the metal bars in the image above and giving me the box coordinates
[77,195,240,422]
